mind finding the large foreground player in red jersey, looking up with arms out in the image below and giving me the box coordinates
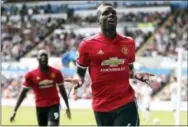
[75,3,153,126]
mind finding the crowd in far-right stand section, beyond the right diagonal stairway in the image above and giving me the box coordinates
[143,10,188,56]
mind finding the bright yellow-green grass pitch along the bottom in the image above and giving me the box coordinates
[1,106,188,126]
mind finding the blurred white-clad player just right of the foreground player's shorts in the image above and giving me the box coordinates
[140,85,152,121]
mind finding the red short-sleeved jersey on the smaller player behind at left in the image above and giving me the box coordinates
[23,66,63,107]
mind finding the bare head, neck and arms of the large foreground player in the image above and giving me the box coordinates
[75,5,154,89]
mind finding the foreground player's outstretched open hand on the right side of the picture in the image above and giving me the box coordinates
[135,73,155,87]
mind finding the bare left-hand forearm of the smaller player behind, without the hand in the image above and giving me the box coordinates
[14,88,29,112]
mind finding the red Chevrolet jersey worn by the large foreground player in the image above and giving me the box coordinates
[77,33,135,112]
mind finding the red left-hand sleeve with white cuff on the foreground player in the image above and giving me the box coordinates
[76,41,89,68]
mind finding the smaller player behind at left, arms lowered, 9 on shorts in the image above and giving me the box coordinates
[10,50,71,126]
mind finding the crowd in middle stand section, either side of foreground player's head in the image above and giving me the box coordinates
[7,12,169,57]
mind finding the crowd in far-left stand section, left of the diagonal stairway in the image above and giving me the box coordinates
[1,18,62,61]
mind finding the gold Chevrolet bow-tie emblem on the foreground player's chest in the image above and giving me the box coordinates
[101,57,125,67]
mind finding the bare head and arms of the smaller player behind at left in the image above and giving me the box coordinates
[10,52,71,126]
